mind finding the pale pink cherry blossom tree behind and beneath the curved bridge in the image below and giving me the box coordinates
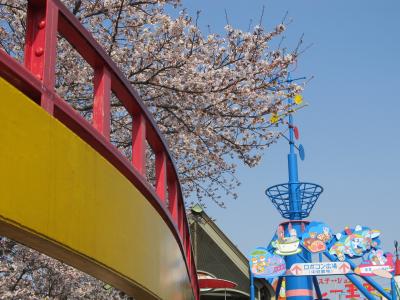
[0,0,302,299]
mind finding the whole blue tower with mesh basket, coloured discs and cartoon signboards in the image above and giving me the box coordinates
[249,77,400,300]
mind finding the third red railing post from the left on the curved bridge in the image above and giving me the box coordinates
[132,114,146,176]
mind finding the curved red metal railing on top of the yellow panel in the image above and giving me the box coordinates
[0,0,198,298]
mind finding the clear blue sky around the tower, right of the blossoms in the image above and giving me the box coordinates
[183,0,400,254]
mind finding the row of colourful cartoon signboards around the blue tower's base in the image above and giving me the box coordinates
[249,221,395,279]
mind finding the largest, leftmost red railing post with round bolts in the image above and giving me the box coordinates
[24,0,58,114]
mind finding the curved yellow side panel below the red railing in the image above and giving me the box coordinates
[0,78,193,300]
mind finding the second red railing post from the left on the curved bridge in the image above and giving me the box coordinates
[93,66,111,141]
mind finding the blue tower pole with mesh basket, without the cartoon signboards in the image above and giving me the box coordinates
[266,95,323,300]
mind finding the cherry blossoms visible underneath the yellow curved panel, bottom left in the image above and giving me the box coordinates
[0,237,132,300]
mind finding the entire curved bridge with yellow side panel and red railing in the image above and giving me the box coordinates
[0,0,199,300]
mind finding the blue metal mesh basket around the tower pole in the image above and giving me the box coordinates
[265,182,323,219]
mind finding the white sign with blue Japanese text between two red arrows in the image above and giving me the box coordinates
[290,262,352,276]
